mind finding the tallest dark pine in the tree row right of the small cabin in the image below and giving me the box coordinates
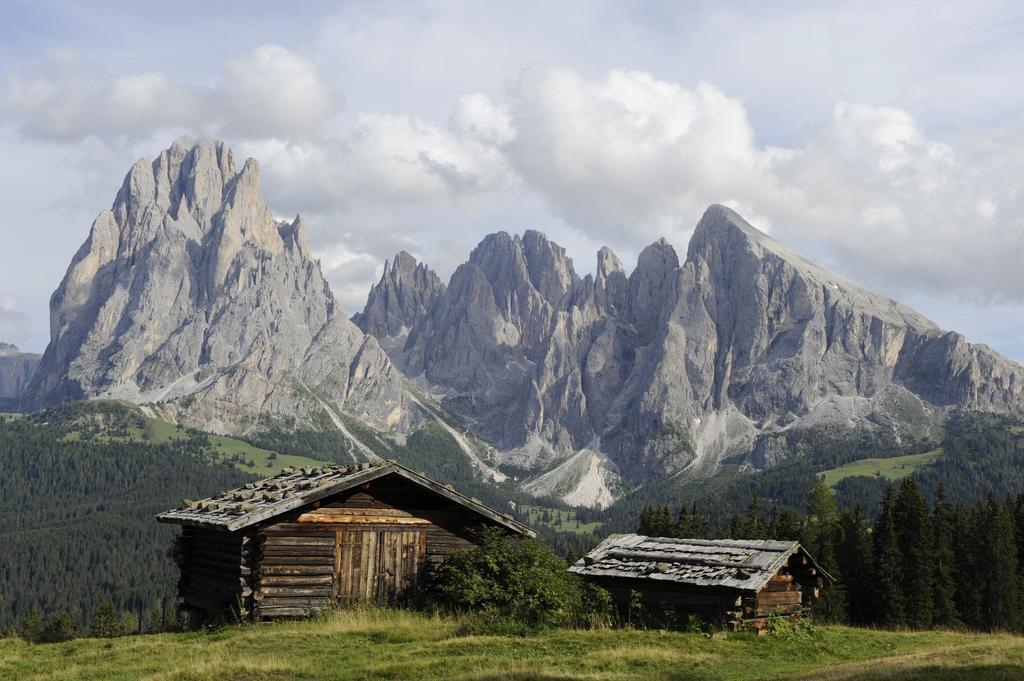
[895,477,935,629]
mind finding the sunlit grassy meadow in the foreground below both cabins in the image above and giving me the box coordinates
[0,610,1024,681]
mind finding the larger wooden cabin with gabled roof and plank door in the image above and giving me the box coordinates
[157,462,535,623]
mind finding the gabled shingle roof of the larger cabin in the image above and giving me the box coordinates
[157,461,536,537]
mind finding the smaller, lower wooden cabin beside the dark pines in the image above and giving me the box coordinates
[569,535,831,629]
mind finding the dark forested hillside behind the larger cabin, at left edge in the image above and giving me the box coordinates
[0,400,331,627]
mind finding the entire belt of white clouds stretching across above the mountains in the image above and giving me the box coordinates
[3,45,1024,319]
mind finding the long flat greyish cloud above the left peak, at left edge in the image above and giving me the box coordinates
[2,45,340,142]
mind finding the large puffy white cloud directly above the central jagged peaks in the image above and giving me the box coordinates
[499,67,765,245]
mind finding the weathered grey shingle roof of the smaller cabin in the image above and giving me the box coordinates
[569,535,827,592]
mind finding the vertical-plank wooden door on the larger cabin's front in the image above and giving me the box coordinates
[334,528,426,604]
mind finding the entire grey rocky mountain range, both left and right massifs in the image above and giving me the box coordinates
[23,137,1024,506]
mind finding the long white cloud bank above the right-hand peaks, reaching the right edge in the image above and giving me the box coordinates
[489,67,1024,301]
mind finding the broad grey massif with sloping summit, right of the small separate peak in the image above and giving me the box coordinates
[362,201,1024,504]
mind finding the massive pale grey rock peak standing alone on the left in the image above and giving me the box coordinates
[25,137,418,440]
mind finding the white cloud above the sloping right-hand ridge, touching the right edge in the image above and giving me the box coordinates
[769,102,1024,301]
